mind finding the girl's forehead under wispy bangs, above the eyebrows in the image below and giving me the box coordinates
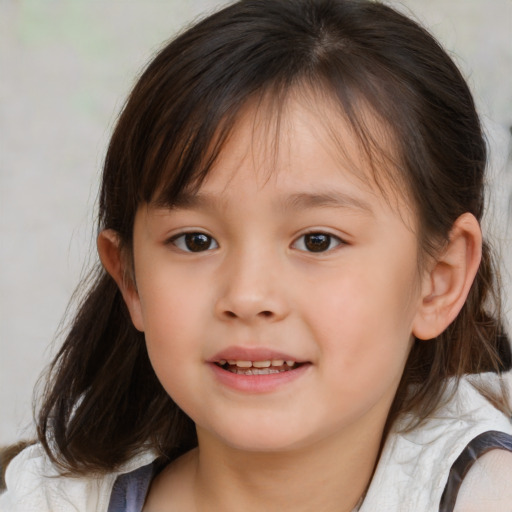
[177,92,409,220]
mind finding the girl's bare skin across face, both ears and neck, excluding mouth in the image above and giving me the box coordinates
[98,94,480,512]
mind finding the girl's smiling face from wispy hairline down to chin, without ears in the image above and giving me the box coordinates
[128,95,421,451]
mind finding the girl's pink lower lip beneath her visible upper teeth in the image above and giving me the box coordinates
[209,363,311,393]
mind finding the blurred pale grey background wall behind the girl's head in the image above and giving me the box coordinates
[0,0,512,445]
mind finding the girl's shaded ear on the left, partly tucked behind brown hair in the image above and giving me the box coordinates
[97,229,144,331]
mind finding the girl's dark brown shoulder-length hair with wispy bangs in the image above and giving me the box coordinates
[34,0,511,473]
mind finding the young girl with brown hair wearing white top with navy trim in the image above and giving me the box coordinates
[0,0,512,512]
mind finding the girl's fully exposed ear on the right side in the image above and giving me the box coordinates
[413,213,482,340]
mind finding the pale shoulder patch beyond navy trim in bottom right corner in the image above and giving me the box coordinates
[454,449,512,512]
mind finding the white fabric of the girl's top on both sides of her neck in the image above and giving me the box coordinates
[0,374,512,512]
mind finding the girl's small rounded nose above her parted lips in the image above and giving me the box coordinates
[215,252,289,323]
